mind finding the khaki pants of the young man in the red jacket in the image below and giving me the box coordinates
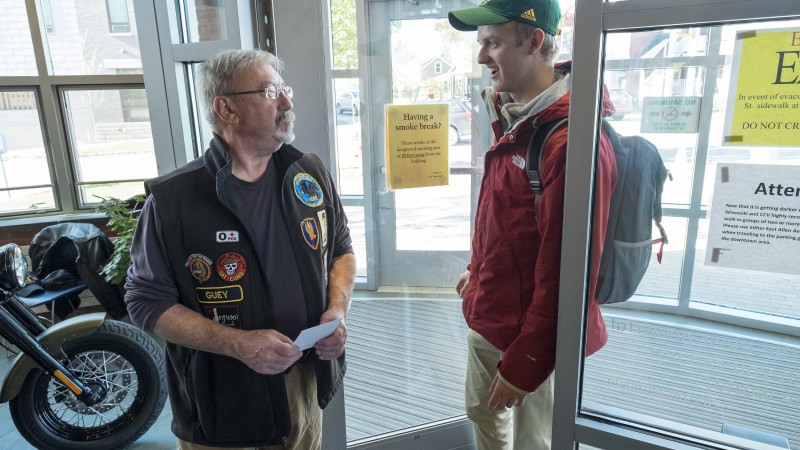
[464,330,553,450]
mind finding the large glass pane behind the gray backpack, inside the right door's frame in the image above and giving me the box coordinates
[568,13,800,448]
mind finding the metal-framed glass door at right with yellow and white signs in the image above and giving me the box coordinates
[553,0,800,449]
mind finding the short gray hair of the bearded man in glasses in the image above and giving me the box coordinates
[197,49,283,129]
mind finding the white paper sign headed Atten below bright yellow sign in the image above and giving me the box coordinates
[706,164,800,275]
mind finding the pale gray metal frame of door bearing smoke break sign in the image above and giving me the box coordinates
[359,0,491,288]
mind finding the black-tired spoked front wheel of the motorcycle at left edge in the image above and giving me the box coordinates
[9,320,167,450]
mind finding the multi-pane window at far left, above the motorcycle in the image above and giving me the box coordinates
[0,0,157,218]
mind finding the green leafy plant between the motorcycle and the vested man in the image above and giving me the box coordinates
[95,194,145,284]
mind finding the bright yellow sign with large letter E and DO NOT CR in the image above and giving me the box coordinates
[724,29,800,146]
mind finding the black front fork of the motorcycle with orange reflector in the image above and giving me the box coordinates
[0,296,103,406]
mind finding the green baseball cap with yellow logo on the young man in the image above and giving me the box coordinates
[447,0,561,35]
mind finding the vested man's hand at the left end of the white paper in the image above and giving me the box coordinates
[235,330,303,375]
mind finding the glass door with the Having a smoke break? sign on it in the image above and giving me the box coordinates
[364,1,488,288]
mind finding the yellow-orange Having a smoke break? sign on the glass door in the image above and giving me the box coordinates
[386,103,449,189]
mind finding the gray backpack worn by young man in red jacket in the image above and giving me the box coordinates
[526,118,672,304]
